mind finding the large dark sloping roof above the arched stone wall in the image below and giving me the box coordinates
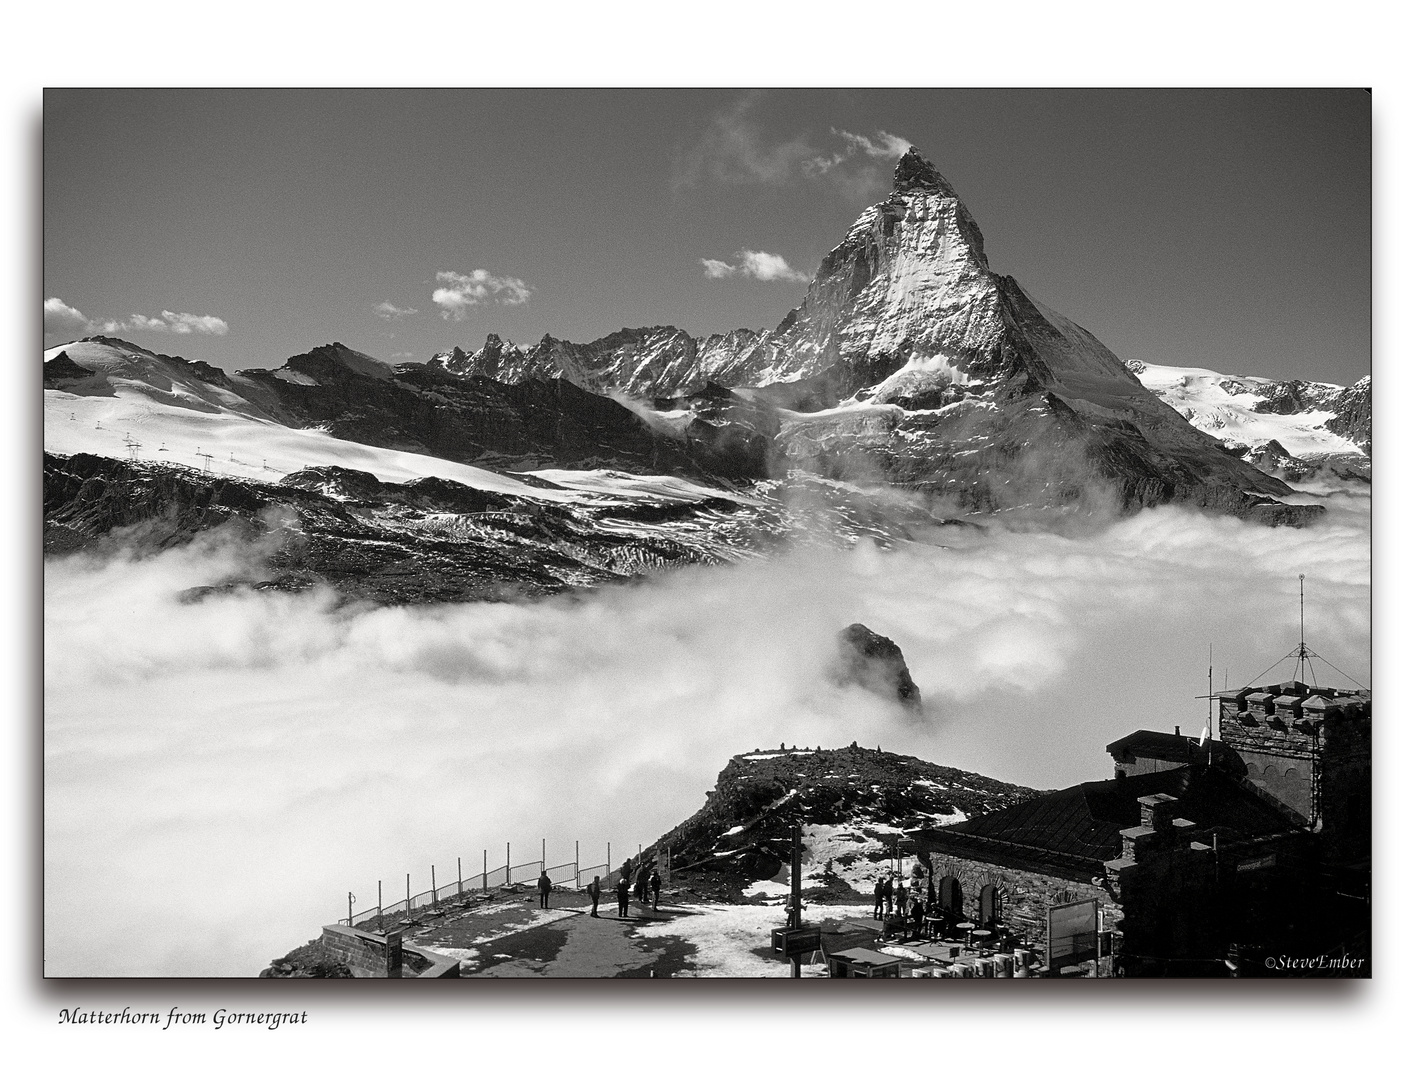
[916,765,1291,874]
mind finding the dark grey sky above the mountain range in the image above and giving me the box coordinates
[44,89,1372,383]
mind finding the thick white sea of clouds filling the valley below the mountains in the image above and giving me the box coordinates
[45,491,1371,975]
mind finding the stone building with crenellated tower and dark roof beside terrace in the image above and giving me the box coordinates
[909,681,1372,977]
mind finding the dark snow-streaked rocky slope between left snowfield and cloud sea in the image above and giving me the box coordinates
[44,454,780,604]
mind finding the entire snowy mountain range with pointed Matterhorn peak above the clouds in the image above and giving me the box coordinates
[44,150,1372,602]
